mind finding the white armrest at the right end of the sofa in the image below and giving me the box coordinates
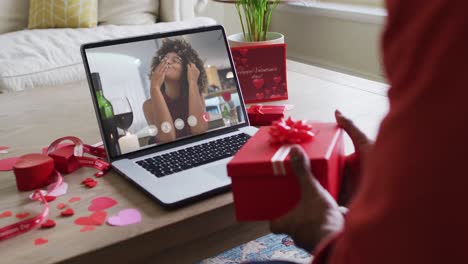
[159,0,208,22]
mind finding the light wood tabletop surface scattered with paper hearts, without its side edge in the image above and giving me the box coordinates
[0,61,388,263]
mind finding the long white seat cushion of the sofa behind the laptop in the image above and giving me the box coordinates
[0,17,216,92]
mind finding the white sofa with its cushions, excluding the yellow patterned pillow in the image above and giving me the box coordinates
[0,0,216,93]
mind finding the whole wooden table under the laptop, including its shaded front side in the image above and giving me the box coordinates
[0,61,388,264]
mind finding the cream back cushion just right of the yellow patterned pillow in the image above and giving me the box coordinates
[98,0,159,25]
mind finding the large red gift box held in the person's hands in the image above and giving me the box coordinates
[227,123,344,221]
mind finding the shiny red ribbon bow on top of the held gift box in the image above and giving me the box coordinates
[269,117,315,145]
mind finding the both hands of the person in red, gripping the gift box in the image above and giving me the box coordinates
[270,111,372,252]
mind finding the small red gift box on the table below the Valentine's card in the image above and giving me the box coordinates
[247,105,286,126]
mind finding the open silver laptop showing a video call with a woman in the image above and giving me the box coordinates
[81,25,257,208]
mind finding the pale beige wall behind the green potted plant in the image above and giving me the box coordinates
[198,1,385,81]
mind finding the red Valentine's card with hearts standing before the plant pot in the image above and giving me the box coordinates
[231,44,288,103]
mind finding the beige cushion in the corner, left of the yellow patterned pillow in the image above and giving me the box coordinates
[0,0,29,34]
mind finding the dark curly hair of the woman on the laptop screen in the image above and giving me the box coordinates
[150,38,208,94]
